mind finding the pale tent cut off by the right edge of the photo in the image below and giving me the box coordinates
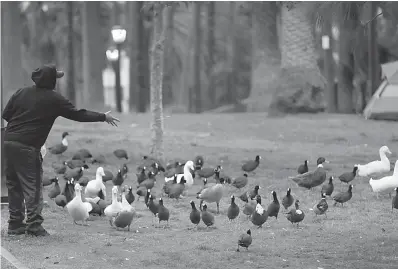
[363,61,398,121]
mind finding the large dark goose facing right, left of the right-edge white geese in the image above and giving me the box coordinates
[290,157,328,190]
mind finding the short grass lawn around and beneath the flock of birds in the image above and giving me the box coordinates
[1,114,398,269]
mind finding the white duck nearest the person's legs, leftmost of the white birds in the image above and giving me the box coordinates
[66,183,93,226]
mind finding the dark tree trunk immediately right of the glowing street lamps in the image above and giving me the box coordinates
[127,1,142,112]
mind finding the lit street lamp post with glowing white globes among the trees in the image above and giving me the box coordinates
[106,26,127,113]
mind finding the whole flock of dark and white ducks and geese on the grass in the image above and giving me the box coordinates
[42,132,398,251]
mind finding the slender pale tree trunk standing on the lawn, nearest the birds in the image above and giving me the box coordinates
[151,3,163,159]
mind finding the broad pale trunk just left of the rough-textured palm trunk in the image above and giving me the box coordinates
[243,2,281,111]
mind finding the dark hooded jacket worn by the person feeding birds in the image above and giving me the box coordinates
[3,65,105,149]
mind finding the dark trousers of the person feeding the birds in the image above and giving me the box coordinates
[3,141,43,232]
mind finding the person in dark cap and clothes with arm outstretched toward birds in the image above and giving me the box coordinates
[2,65,119,236]
